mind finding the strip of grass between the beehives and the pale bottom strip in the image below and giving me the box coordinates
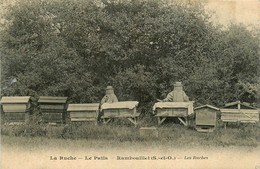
[1,120,260,147]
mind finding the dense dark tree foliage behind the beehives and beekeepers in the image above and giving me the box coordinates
[0,0,260,111]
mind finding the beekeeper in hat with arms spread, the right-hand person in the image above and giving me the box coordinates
[163,82,189,102]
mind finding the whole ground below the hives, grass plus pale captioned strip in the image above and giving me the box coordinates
[1,123,260,169]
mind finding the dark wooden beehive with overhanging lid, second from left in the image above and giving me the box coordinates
[38,96,67,124]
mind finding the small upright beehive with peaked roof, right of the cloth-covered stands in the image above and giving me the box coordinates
[194,105,219,132]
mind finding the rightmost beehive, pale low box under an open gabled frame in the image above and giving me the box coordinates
[220,101,259,123]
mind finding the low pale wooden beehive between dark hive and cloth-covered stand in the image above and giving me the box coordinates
[67,103,99,122]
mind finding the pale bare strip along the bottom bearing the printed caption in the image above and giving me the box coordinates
[1,137,260,169]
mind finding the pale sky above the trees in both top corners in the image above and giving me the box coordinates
[0,0,260,28]
